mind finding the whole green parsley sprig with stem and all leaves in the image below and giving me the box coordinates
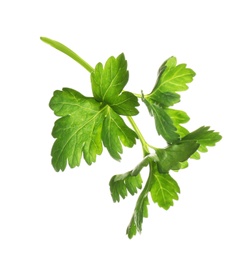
[41,37,222,238]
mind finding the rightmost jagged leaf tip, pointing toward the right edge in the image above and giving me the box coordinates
[182,126,222,152]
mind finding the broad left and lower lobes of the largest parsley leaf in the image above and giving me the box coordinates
[50,88,137,171]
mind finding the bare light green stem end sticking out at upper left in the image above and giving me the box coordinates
[40,37,94,73]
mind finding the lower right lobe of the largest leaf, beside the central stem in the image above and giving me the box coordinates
[102,107,138,160]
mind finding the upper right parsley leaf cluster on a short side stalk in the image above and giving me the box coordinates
[143,57,195,144]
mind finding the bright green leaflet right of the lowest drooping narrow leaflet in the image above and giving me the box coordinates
[151,171,180,210]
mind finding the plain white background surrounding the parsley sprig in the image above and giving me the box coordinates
[0,0,247,260]
